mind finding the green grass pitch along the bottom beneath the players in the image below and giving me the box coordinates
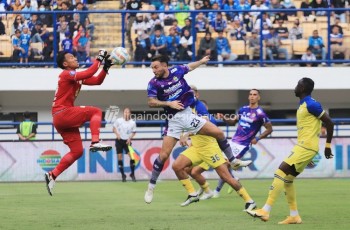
[0,179,350,230]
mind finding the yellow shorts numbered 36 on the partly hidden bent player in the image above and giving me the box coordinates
[181,143,226,169]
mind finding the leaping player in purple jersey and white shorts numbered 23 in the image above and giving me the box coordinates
[144,55,251,204]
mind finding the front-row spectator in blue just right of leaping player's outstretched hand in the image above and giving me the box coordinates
[215,31,237,67]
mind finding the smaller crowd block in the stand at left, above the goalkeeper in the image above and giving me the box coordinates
[0,0,96,63]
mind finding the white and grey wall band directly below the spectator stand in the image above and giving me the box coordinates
[0,67,350,122]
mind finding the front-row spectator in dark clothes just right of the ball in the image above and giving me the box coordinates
[134,29,152,67]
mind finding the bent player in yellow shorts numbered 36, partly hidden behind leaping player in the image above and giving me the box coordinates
[173,106,256,210]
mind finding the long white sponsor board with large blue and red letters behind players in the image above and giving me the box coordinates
[0,138,350,182]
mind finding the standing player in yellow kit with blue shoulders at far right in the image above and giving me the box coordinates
[247,78,334,224]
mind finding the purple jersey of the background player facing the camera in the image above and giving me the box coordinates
[232,105,270,146]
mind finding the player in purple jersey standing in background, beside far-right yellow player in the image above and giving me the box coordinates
[213,89,272,198]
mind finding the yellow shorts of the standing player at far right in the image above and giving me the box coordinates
[284,145,317,173]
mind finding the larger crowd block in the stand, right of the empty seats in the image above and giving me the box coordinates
[124,0,350,66]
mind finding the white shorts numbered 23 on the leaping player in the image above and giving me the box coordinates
[165,107,207,139]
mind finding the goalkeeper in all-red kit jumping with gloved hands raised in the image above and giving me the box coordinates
[45,50,112,196]
